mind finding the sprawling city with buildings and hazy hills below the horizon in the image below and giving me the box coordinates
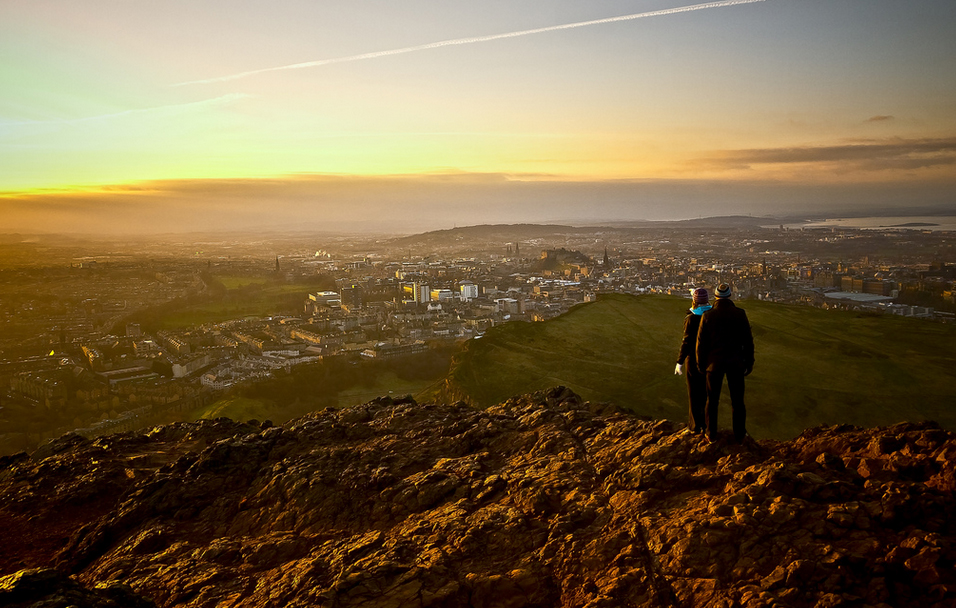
[0,217,956,451]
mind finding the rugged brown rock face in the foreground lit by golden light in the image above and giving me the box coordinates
[0,389,956,608]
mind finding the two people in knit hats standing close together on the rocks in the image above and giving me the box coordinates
[674,283,754,443]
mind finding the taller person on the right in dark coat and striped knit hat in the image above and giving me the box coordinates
[696,283,754,442]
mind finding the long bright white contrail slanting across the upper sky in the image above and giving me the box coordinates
[173,0,764,87]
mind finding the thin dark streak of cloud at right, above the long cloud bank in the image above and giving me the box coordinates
[699,137,956,171]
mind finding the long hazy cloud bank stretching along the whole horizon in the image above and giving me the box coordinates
[0,173,956,236]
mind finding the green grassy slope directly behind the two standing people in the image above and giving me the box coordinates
[444,294,956,439]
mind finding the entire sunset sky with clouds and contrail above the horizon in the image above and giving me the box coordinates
[0,0,956,234]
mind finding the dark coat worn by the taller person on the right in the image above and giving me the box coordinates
[696,298,754,373]
